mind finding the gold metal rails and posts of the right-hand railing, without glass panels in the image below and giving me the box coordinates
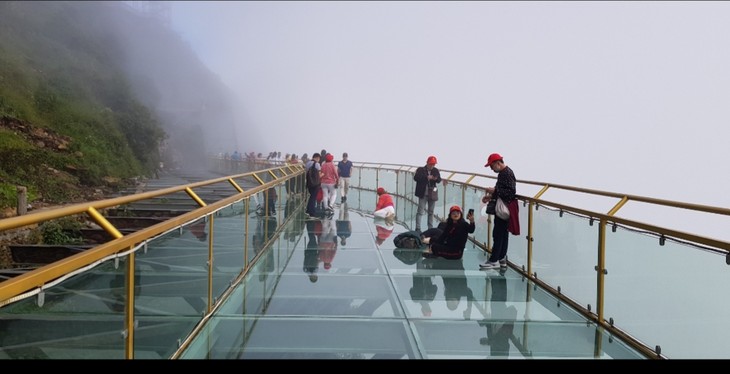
[354,162,730,357]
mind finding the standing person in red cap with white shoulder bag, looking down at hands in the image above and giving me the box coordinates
[479,153,517,269]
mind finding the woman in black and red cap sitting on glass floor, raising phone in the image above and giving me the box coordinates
[423,205,476,260]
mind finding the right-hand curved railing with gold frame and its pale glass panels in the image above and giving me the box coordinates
[348,163,730,358]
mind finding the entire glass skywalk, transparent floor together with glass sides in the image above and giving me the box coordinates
[0,164,730,359]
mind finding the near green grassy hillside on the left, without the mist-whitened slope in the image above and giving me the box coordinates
[0,2,166,207]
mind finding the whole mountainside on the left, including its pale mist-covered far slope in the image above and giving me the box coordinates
[0,1,247,206]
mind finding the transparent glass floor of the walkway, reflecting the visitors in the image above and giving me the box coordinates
[181,203,643,359]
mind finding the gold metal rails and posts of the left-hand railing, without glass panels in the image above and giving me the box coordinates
[0,165,303,359]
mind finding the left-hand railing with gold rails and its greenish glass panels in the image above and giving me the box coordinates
[0,161,302,359]
